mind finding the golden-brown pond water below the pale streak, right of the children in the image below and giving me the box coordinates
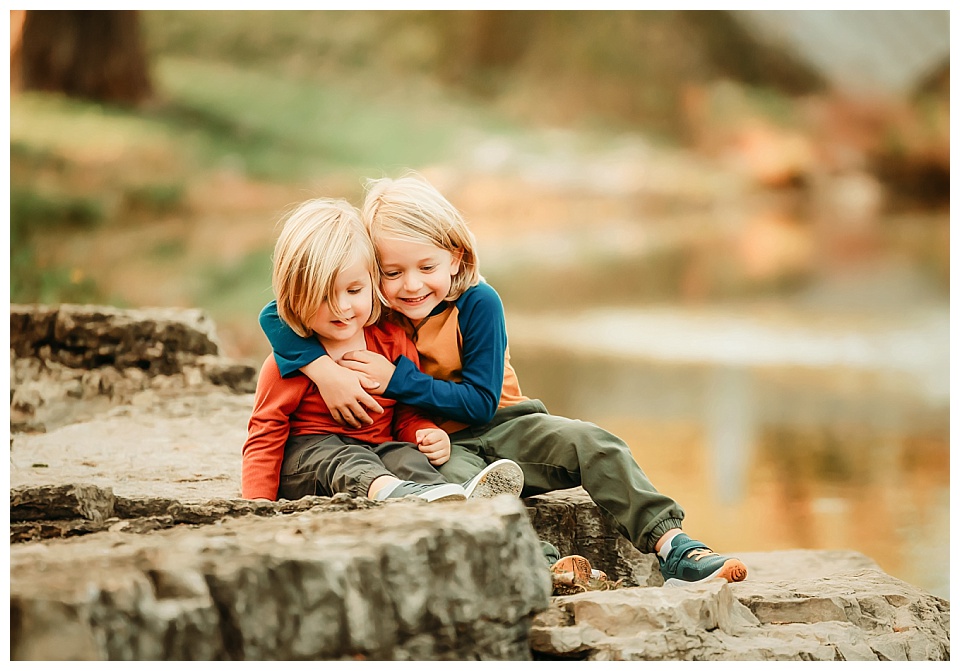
[511,346,950,598]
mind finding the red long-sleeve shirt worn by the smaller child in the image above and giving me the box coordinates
[241,322,437,501]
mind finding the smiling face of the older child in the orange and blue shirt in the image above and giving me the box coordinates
[377,238,460,321]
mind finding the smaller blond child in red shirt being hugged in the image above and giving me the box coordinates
[241,198,466,501]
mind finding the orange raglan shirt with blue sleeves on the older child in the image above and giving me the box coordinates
[260,282,527,433]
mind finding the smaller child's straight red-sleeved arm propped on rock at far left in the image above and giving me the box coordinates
[240,357,302,501]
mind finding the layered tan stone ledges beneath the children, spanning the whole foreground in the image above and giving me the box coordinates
[10,306,950,660]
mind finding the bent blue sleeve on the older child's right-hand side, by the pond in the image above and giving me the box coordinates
[384,283,507,424]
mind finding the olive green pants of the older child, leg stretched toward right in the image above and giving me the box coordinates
[439,400,683,552]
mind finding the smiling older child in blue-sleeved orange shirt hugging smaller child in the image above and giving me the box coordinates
[260,174,747,584]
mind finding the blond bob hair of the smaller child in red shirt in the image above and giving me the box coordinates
[273,198,383,338]
